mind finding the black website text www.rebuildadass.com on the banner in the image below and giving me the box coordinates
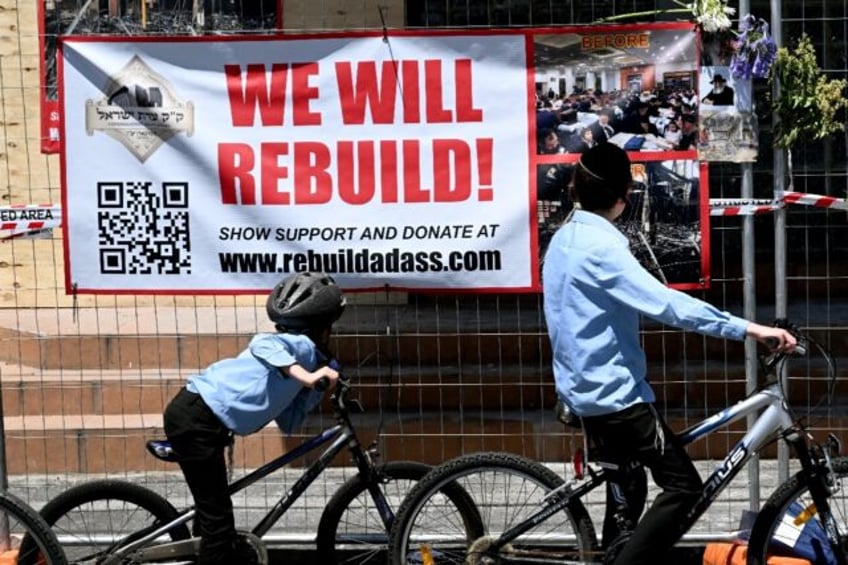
[218,248,501,274]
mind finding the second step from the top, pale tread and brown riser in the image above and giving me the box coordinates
[0,360,836,417]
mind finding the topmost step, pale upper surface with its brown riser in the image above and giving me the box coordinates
[9,302,828,371]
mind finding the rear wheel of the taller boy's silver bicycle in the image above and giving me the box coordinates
[389,453,597,565]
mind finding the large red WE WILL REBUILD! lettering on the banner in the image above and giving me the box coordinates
[218,59,494,205]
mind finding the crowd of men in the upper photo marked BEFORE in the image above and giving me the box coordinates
[536,85,699,154]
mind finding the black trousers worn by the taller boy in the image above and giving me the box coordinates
[583,404,703,565]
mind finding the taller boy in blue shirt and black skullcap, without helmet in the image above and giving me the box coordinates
[542,143,796,565]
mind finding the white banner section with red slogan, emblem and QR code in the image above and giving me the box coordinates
[60,34,538,293]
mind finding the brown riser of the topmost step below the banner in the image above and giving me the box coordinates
[0,327,848,371]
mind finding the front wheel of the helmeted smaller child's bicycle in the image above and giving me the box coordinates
[315,461,476,564]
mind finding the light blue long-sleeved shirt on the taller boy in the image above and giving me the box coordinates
[542,210,748,416]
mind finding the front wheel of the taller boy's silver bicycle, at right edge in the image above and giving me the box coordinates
[748,457,848,565]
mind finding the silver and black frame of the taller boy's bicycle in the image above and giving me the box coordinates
[489,374,826,549]
